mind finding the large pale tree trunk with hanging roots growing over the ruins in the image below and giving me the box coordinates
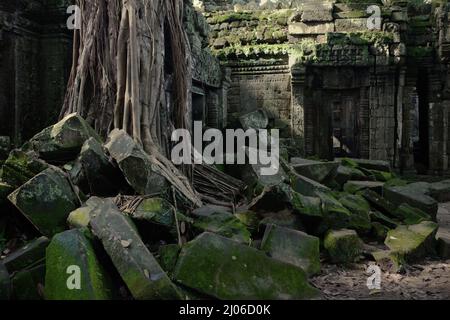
[61,0,201,206]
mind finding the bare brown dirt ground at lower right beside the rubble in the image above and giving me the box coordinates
[312,203,450,300]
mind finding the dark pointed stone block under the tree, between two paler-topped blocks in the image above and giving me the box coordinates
[70,138,123,196]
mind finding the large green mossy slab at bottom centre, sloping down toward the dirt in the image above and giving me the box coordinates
[174,233,318,300]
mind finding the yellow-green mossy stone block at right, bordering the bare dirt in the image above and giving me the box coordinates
[385,221,438,262]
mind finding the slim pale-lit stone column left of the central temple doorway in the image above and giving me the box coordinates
[291,66,306,154]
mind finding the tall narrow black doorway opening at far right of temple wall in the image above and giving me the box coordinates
[414,69,430,174]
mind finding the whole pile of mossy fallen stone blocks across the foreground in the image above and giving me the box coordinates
[0,115,450,300]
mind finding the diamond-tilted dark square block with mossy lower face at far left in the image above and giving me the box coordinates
[8,168,79,237]
